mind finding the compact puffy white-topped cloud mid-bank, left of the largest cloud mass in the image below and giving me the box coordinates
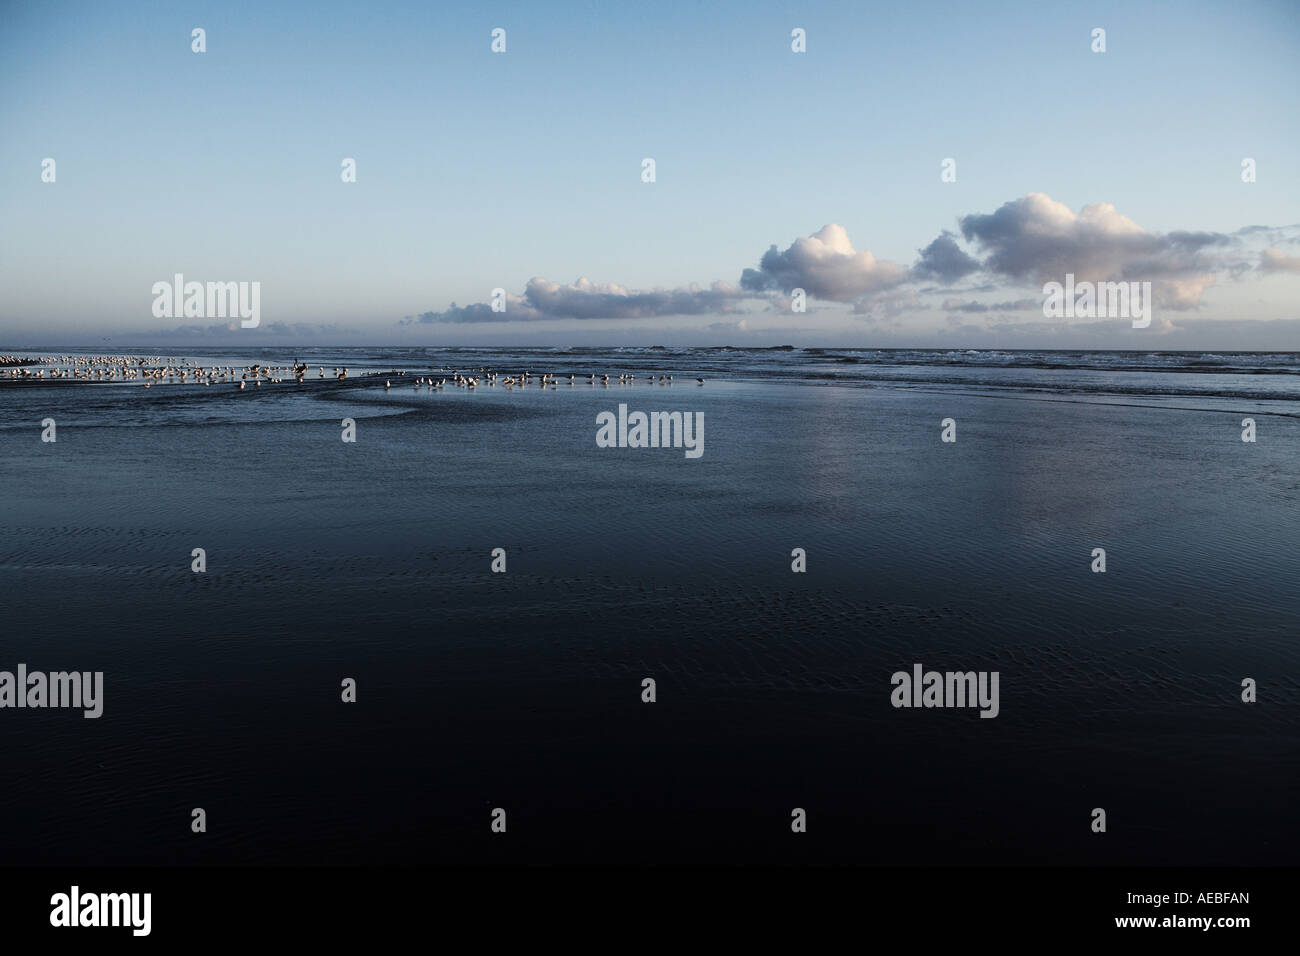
[740,222,907,302]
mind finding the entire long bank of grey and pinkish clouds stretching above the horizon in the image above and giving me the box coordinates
[402,200,1300,325]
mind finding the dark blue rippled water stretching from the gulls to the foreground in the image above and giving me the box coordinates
[0,349,1300,864]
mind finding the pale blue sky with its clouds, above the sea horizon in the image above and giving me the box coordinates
[0,0,1300,350]
